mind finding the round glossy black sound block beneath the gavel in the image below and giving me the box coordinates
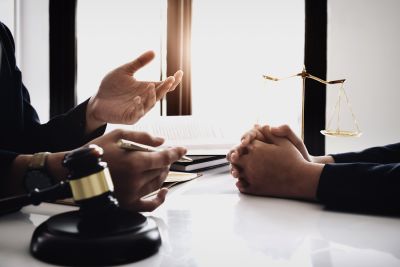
[30,209,161,266]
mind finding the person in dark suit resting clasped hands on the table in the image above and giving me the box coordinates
[227,125,400,214]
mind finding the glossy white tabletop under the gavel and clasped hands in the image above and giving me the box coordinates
[0,167,400,267]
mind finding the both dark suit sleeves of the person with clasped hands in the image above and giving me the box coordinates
[317,143,400,214]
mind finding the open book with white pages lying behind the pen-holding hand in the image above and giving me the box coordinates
[107,116,250,156]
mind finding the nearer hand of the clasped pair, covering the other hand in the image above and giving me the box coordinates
[230,137,323,199]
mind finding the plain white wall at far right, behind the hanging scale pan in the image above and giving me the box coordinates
[326,0,400,153]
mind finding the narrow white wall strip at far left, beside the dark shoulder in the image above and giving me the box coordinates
[0,0,49,122]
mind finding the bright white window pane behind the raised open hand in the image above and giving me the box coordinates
[77,0,166,118]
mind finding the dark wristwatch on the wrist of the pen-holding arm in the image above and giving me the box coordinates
[24,152,54,193]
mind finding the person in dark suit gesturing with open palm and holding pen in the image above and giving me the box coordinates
[0,22,186,211]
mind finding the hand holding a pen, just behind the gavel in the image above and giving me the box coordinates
[90,130,186,211]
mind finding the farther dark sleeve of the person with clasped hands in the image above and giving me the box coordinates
[331,143,400,163]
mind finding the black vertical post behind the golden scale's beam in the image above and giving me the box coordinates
[304,0,328,155]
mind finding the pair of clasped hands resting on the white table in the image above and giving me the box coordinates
[227,125,324,200]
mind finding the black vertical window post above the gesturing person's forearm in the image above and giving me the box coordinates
[49,0,77,117]
